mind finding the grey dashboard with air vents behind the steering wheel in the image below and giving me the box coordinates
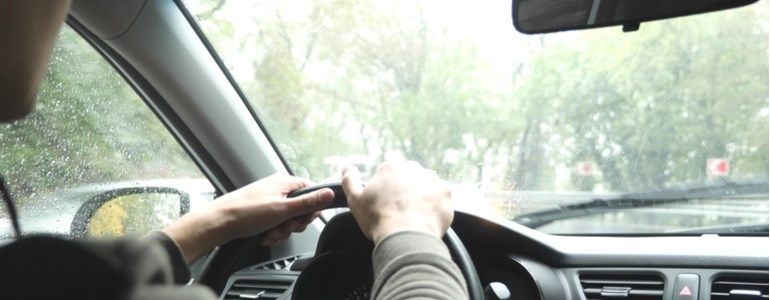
[221,212,770,300]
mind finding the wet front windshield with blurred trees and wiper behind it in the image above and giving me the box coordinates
[184,0,770,234]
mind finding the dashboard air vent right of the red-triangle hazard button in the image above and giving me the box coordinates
[711,274,768,300]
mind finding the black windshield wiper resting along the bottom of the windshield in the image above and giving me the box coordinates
[513,181,769,228]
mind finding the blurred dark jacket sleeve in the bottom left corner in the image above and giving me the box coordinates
[0,232,217,300]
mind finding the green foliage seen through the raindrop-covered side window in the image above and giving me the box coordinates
[0,28,201,207]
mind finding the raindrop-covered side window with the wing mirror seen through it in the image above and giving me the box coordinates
[0,28,214,239]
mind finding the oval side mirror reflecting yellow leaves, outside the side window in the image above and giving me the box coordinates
[70,187,190,238]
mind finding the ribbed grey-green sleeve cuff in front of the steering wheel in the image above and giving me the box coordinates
[372,232,468,300]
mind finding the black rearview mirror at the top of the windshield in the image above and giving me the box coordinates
[512,0,757,34]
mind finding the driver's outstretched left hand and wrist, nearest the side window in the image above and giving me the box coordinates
[163,174,334,262]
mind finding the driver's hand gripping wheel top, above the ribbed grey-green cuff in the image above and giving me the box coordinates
[342,161,454,244]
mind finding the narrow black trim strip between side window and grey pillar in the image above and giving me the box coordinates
[66,16,235,196]
